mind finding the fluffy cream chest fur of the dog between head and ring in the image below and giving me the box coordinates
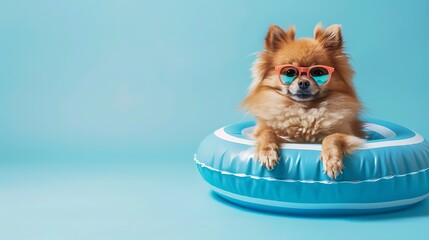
[264,104,352,142]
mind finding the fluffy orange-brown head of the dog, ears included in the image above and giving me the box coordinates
[243,24,355,108]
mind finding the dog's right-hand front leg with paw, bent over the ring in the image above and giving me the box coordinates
[321,133,365,179]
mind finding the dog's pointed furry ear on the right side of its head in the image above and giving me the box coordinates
[314,23,343,50]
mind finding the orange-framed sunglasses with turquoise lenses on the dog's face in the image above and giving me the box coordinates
[275,64,334,86]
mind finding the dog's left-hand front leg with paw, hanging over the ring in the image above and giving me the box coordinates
[254,122,280,170]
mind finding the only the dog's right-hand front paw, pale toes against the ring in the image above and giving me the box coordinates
[321,147,344,179]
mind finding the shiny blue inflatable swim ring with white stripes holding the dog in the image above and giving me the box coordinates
[194,119,429,214]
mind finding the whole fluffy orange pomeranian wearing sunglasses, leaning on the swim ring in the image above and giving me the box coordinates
[242,24,364,179]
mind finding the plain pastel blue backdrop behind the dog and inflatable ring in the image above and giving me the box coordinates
[0,0,429,240]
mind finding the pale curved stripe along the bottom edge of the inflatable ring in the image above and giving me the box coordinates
[210,185,429,210]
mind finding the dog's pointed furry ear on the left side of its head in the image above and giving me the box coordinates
[265,25,295,52]
